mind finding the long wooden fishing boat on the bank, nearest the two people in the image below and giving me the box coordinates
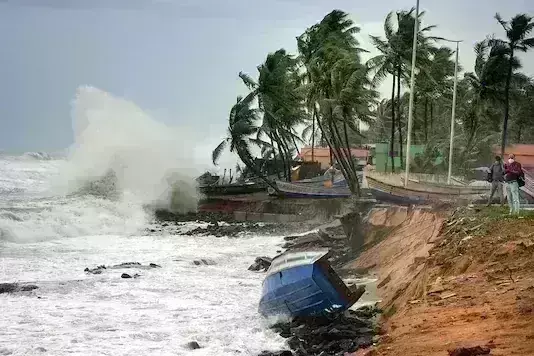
[366,175,488,204]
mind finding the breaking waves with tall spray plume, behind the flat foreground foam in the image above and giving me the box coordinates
[0,87,203,242]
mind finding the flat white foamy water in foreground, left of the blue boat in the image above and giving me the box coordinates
[0,228,283,356]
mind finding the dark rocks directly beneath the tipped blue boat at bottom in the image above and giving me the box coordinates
[268,308,379,356]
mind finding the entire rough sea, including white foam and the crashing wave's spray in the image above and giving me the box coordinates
[0,87,284,356]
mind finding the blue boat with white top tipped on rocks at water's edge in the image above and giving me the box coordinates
[259,250,363,317]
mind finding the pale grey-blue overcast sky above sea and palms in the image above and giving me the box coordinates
[0,0,534,167]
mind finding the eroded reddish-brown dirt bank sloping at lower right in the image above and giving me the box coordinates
[346,208,534,356]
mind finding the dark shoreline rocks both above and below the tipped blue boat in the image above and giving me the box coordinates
[249,211,381,356]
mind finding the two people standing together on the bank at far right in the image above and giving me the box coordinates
[488,154,524,215]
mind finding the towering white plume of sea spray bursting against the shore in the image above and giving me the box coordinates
[57,87,199,212]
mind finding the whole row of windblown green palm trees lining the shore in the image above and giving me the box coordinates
[213,9,534,189]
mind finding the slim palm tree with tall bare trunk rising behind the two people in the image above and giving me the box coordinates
[490,13,534,155]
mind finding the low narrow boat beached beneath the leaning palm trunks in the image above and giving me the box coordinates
[268,181,351,198]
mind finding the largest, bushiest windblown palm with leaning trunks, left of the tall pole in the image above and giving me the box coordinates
[299,10,375,195]
